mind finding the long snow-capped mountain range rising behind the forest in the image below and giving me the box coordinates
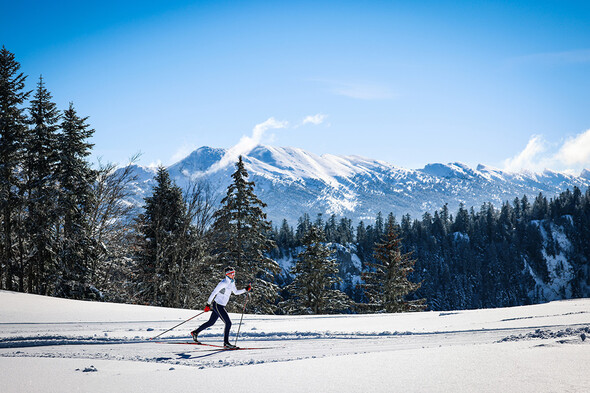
[127,146,590,225]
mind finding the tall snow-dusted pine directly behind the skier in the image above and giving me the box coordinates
[211,156,280,313]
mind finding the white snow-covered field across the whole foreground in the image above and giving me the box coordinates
[0,291,590,393]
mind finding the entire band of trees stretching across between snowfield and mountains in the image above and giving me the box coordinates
[0,47,590,314]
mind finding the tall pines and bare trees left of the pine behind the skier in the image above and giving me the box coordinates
[0,47,220,307]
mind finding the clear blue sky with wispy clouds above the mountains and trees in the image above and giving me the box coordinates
[0,0,590,173]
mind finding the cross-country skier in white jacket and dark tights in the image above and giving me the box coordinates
[191,267,252,349]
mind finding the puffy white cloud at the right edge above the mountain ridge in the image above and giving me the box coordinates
[504,130,590,174]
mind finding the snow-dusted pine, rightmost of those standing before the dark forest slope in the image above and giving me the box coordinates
[362,225,426,312]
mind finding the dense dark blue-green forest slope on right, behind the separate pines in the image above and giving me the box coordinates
[273,187,590,310]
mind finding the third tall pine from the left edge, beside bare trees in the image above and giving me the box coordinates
[57,103,98,298]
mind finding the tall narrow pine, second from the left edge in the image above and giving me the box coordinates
[24,77,60,295]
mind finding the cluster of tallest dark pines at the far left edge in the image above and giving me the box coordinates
[0,47,102,296]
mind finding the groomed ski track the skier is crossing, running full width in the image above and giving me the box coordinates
[0,313,590,369]
